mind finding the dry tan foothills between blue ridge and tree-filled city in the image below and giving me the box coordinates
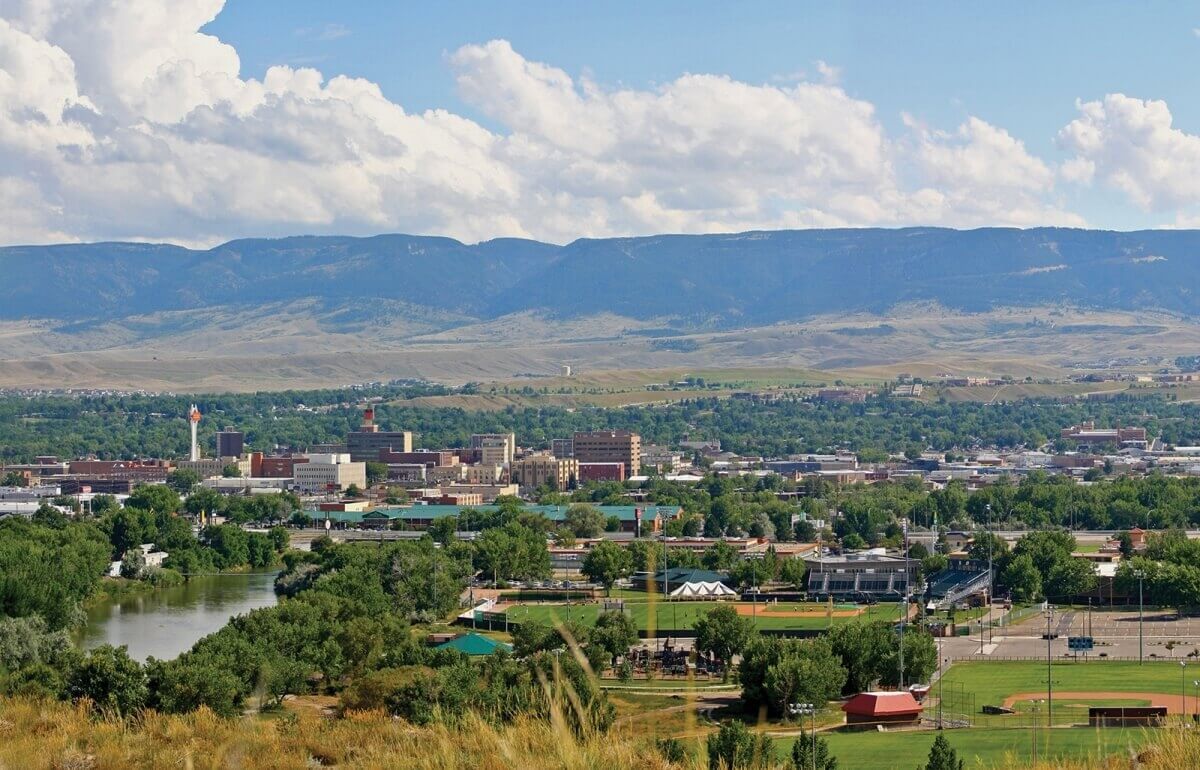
[0,302,1200,393]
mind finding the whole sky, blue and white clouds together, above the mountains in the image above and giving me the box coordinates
[0,0,1200,247]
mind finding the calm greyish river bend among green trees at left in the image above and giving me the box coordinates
[78,572,276,661]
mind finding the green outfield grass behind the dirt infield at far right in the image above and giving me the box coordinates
[942,661,1192,710]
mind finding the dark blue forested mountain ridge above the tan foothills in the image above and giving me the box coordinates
[0,228,1200,327]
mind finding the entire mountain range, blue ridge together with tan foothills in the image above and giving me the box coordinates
[0,228,1200,390]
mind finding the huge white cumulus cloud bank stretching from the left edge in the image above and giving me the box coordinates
[0,0,1089,243]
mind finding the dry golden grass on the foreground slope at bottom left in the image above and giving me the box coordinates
[0,699,686,770]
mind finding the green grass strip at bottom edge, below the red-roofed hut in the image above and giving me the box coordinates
[775,728,1154,770]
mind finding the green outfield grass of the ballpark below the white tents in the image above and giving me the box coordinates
[508,601,900,631]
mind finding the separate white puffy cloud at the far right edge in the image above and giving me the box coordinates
[1058,94,1200,213]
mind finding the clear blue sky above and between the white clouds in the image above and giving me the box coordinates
[201,0,1200,229]
